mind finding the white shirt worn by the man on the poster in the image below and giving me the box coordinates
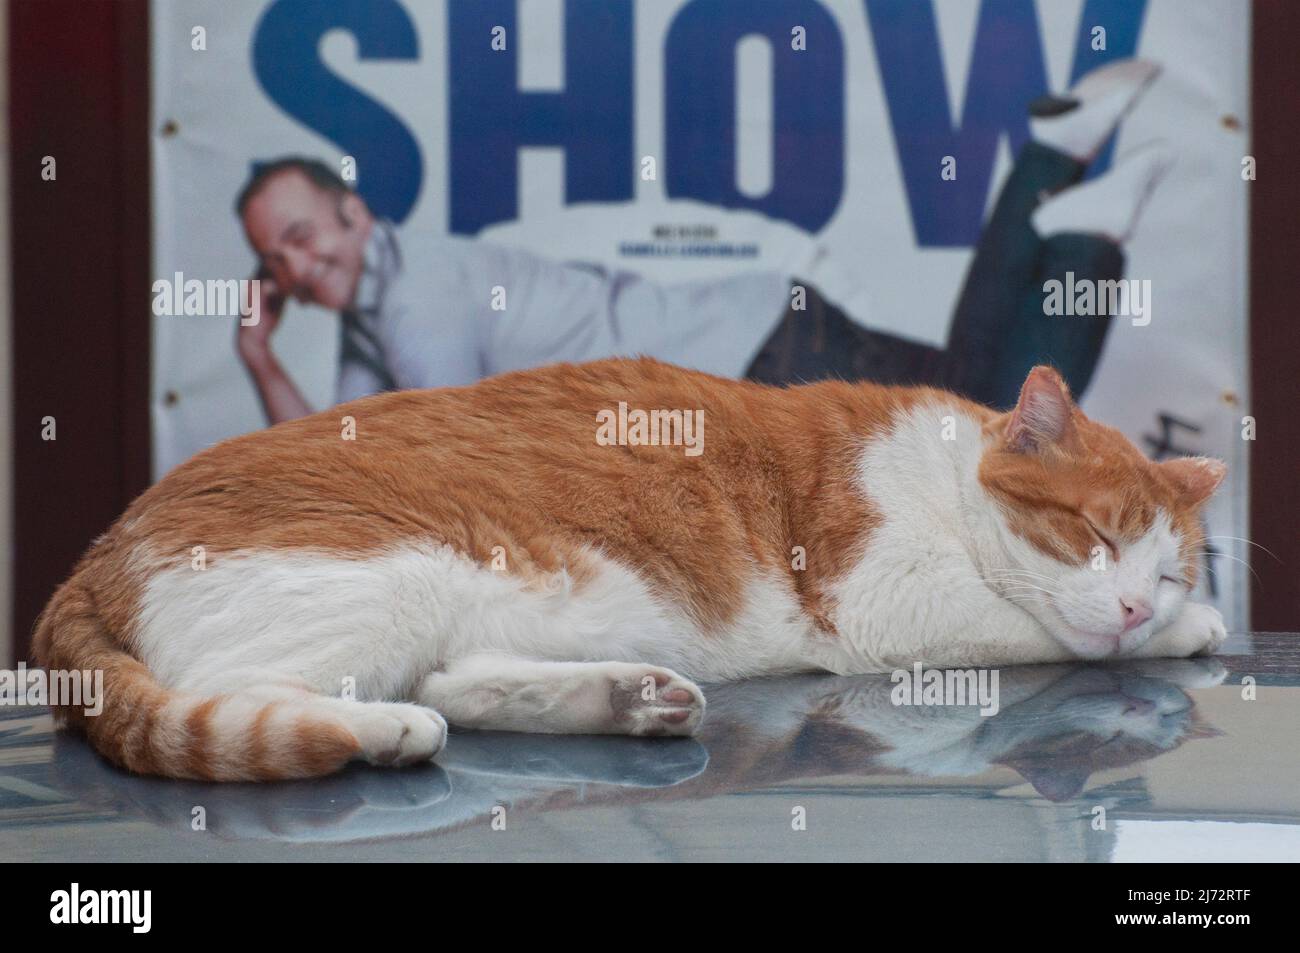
[337,221,790,403]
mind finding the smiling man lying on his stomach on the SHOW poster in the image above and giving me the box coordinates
[237,60,1171,423]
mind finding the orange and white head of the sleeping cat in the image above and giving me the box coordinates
[979,367,1226,658]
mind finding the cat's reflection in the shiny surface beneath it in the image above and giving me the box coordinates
[45,659,1226,841]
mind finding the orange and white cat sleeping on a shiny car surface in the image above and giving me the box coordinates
[34,359,1225,780]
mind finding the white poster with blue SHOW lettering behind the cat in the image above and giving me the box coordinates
[144,0,1251,631]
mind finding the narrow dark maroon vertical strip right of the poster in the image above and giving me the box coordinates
[1249,0,1300,632]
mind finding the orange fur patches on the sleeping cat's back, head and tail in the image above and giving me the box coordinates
[34,360,1222,777]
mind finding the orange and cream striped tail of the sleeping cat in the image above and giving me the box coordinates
[33,576,361,781]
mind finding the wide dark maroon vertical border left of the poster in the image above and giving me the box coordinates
[9,0,150,658]
